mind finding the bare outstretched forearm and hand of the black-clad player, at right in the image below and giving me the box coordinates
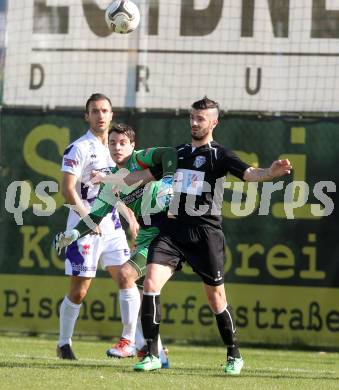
[243,159,292,182]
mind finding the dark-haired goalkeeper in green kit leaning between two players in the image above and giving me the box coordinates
[57,124,177,367]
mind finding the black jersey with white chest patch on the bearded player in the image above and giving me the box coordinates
[171,141,250,226]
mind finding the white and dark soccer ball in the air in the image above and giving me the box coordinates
[105,0,140,34]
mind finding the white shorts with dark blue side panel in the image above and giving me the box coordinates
[65,229,130,278]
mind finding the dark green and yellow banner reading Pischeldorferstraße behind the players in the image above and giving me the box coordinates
[0,111,339,346]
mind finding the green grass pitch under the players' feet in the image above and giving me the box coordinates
[0,336,339,390]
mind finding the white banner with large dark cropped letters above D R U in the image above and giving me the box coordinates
[4,0,339,113]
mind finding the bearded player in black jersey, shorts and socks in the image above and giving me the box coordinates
[134,97,292,375]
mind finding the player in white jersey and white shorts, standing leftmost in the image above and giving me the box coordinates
[57,94,140,360]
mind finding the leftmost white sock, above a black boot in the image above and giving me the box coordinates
[59,296,81,347]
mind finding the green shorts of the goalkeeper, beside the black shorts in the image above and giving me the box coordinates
[128,227,159,278]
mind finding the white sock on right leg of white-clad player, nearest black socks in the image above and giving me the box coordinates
[119,286,140,343]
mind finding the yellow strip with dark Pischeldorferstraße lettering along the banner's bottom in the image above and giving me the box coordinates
[0,275,339,347]
